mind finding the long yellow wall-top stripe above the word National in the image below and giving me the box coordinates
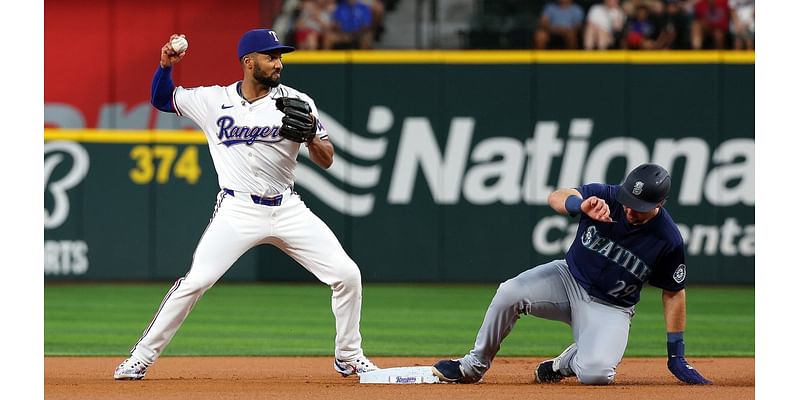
[283,50,756,64]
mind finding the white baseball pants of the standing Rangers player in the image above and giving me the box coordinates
[131,191,363,364]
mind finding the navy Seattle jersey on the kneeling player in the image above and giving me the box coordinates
[566,183,686,307]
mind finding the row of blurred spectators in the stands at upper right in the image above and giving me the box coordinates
[534,0,755,50]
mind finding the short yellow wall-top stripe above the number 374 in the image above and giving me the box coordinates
[44,129,206,144]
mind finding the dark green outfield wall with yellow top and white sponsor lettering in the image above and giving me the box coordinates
[44,52,755,284]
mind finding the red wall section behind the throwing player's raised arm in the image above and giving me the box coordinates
[44,0,268,129]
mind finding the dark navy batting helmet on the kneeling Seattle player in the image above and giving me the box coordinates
[617,164,672,212]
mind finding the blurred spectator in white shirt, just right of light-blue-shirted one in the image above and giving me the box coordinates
[583,0,625,50]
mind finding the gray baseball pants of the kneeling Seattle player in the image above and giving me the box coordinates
[459,260,634,385]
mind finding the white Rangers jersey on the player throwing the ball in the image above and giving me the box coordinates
[172,82,328,196]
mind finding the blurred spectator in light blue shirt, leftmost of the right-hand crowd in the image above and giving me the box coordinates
[534,0,584,49]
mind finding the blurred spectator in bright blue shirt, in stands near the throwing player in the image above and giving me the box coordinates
[323,0,373,49]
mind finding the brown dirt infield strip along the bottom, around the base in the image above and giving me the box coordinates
[44,357,755,400]
